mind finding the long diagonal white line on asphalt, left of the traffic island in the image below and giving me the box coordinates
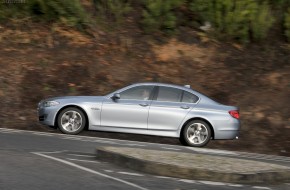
[32,152,148,190]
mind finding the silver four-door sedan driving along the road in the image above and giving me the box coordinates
[38,83,240,147]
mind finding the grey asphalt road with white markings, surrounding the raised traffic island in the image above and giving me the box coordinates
[0,128,290,190]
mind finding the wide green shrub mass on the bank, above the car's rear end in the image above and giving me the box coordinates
[190,0,274,42]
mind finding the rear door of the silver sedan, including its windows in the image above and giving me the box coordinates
[148,86,198,131]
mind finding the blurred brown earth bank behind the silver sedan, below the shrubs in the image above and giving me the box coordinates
[0,18,290,156]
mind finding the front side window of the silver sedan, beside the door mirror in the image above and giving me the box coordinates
[120,86,153,100]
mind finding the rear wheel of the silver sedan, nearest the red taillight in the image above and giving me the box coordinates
[180,120,211,147]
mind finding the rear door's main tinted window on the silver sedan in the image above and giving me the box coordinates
[157,86,182,102]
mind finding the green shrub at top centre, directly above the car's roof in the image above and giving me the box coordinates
[142,0,184,33]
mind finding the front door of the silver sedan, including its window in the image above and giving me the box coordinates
[101,85,154,129]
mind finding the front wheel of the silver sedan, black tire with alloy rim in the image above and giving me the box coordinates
[57,107,87,135]
